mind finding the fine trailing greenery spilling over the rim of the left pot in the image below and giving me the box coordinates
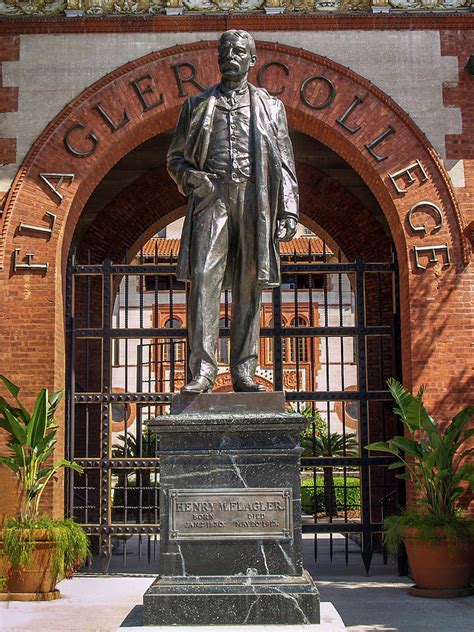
[3,516,90,578]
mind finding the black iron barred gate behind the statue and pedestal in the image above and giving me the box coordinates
[67,240,404,572]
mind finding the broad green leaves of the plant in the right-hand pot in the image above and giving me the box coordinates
[366,379,474,529]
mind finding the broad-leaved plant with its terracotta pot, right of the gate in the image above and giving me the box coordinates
[366,379,474,597]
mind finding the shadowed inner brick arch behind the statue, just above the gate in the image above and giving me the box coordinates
[76,163,391,263]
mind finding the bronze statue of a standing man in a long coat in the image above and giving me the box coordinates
[168,30,298,393]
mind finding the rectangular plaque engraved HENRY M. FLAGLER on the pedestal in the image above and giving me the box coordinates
[169,488,293,540]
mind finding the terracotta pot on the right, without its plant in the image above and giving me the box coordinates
[404,529,473,598]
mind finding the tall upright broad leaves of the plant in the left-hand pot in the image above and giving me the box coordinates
[0,375,83,521]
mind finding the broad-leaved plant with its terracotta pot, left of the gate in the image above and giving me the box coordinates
[0,375,89,601]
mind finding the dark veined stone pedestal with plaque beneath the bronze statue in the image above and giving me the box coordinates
[143,393,319,625]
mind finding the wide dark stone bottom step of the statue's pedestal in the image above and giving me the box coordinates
[143,572,320,625]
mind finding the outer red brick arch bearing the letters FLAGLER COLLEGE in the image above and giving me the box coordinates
[0,42,470,444]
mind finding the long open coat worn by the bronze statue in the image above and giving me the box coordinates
[168,84,298,287]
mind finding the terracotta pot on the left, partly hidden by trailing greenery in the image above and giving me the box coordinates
[7,529,59,601]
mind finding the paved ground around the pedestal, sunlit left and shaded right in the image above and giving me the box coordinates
[0,536,474,632]
